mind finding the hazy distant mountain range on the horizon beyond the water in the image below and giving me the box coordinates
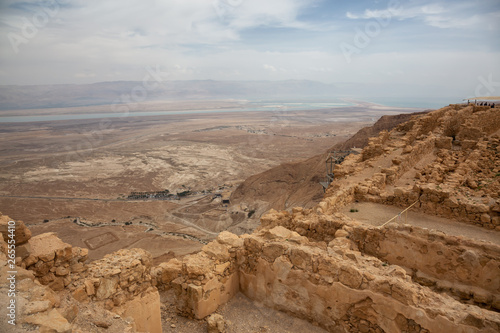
[0,80,338,110]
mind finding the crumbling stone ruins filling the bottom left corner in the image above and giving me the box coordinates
[0,214,162,333]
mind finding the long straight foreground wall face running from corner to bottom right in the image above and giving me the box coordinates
[240,227,500,332]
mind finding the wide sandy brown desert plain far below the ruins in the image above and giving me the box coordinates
[0,101,424,260]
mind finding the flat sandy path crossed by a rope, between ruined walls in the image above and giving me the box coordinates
[341,202,500,245]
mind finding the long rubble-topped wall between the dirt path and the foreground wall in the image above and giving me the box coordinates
[262,208,500,311]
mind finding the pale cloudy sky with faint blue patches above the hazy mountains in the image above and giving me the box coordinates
[0,0,500,97]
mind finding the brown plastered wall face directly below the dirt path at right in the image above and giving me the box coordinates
[350,224,500,311]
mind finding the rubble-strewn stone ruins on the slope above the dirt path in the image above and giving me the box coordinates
[330,105,500,230]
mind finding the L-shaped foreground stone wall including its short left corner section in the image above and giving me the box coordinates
[156,224,500,332]
